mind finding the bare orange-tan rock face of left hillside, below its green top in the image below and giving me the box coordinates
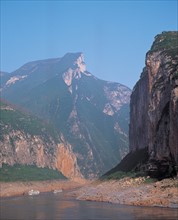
[0,131,83,179]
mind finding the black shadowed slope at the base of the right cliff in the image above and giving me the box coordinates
[101,148,177,180]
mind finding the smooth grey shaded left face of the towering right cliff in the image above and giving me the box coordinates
[129,68,149,151]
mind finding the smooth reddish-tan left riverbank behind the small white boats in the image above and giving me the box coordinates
[0,180,85,197]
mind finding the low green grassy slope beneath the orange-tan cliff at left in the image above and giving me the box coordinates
[0,164,66,182]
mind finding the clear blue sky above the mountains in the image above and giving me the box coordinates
[0,0,178,88]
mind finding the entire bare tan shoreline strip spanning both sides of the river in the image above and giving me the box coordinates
[0,177,178,208]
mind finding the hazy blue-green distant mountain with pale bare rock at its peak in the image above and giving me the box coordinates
[1,53,131,178]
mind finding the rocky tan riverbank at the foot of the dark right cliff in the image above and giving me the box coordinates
[72,177,178,208]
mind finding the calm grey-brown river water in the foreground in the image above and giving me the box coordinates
[0,193,178,220]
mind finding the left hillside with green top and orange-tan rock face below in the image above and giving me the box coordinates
[0,101,82,179]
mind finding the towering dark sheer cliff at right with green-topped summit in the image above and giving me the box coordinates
[129,32,178,179]
